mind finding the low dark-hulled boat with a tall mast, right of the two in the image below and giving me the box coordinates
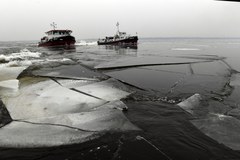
[97,23,138,45]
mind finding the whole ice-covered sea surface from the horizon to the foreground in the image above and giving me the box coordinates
[0,39,240,160]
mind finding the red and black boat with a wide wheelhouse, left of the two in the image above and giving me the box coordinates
[38,23,76,47]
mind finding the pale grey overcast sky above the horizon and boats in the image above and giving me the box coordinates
[0,0,240,41]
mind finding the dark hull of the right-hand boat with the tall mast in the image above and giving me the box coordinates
[97,36,138,45]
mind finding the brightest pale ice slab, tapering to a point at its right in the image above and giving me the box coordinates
[3,78,106,119]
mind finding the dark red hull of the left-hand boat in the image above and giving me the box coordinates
[38,36,76,47]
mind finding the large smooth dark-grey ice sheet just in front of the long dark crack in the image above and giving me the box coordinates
[105,61,230,96]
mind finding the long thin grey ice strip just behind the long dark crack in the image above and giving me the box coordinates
[95,56,209,69]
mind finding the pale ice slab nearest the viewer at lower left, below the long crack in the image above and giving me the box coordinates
[0,103,139,148]
